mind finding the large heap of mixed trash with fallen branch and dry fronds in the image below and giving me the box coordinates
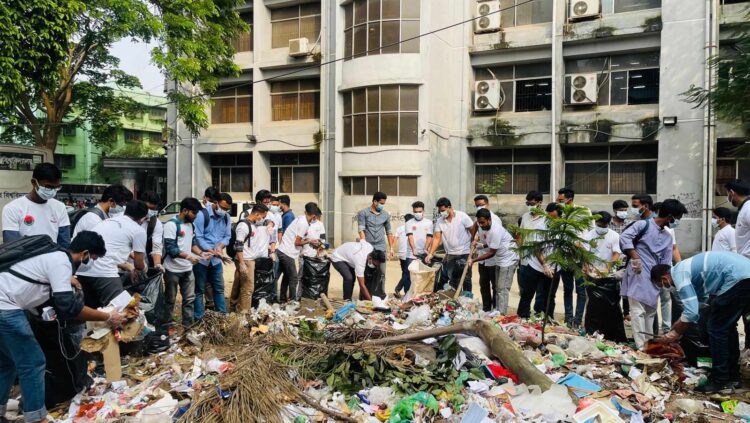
[27,292,750,423]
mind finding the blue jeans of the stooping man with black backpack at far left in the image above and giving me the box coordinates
[0,310,47,422]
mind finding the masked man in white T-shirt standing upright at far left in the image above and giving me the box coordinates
[2,163,70,248]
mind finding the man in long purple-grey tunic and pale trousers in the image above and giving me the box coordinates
[620,199,687,349]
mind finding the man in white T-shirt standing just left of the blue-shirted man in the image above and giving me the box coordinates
[164,197,203,327]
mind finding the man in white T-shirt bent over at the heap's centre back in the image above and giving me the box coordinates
[330,240,385,301]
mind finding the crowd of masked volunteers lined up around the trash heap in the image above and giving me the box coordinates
[0,163,750,422]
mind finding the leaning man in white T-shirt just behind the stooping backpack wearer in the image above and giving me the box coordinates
[76,200,148,308]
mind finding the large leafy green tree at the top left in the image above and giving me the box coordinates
[0,0,247,152]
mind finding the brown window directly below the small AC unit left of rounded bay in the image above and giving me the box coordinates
[271,79,320,121]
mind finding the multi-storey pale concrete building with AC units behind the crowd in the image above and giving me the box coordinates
[168,0,750,252]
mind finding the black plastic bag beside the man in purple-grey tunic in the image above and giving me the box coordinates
[584,278,628,342]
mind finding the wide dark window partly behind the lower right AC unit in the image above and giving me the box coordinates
[565,51,659,106]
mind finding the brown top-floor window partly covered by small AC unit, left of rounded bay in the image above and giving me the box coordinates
[271,3,320,48]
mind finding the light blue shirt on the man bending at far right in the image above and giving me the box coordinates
[672,251,750,323]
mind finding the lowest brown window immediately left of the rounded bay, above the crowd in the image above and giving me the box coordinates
[271,153,320,194]
